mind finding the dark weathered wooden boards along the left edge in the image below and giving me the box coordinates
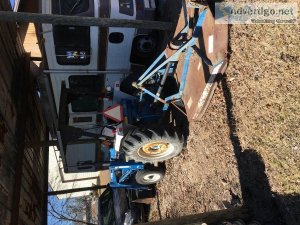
[0,0,47,225]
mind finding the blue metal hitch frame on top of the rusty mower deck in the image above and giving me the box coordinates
[132,5,214,111]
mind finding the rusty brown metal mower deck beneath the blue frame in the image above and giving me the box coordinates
[167,2,228,121]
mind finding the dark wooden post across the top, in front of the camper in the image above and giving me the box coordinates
[0,11,175,31]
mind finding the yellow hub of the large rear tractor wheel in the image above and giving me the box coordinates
[139,142,169,158]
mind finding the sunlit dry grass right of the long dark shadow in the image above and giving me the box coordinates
[227,21,300,194]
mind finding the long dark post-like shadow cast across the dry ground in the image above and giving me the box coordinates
[221,76,300,225]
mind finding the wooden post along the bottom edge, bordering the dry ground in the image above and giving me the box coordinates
[141,207,249,225]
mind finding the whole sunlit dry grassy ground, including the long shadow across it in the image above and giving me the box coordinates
[150,1,300,225]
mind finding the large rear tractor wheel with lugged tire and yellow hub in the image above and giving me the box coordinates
[122,127,184,163]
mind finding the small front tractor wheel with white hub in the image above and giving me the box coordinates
[135,167,165,185]
